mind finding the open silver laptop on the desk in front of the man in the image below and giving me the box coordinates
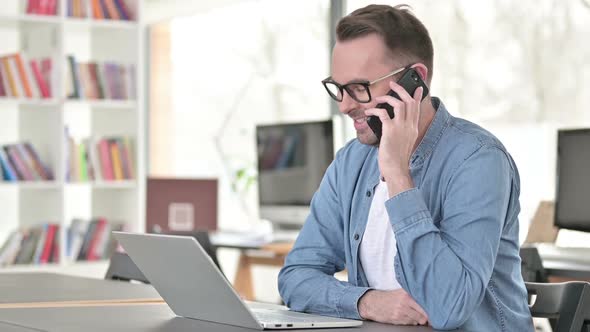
[113,232,362,330]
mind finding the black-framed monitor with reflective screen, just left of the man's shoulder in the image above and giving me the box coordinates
[256,120,334,229]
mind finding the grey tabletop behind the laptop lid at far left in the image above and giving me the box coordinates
[0,273,161,307]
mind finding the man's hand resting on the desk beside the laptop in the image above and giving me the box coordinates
[358,288,428,325]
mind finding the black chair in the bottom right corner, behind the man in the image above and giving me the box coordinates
[525,281,590,332]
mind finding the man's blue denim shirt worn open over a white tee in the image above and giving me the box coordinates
[279,98,534,332]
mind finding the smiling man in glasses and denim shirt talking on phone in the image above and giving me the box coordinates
[279,5,533,331]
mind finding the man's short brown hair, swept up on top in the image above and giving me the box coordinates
[336,5,434,81]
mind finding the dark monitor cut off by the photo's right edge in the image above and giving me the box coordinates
[555,129,590,232]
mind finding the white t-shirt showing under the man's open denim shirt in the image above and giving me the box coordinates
[360,181,401,290]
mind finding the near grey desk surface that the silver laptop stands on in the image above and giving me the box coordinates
[0,304,446,332]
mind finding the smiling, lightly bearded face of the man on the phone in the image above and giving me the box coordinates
[332,34,395,145]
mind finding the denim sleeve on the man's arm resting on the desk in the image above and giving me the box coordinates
[278,158,369,319]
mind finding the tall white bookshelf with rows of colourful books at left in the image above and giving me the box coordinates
[0,0,146,275]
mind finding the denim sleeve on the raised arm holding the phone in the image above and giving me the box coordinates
[386,146,518,329]
